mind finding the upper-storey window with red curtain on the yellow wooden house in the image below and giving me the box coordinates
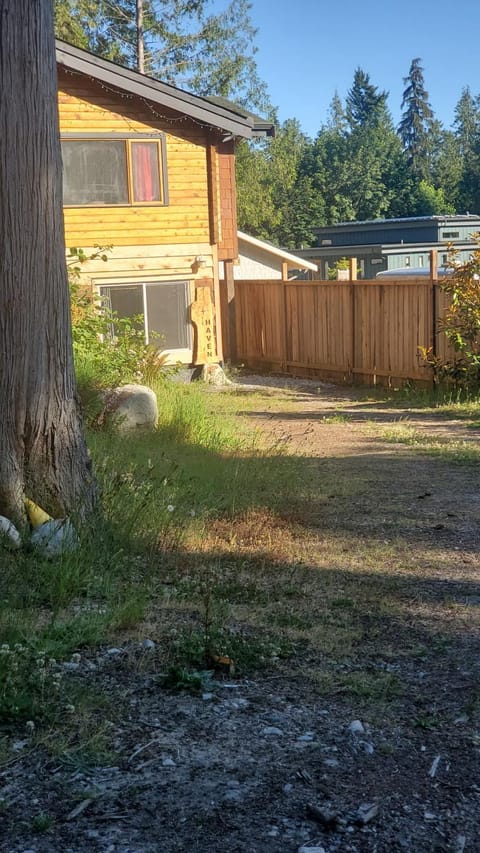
[62,134,167,207]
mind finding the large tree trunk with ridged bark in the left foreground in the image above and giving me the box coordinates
[0,0,96,521]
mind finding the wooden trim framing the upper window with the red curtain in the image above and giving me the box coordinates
[60,131,170,210]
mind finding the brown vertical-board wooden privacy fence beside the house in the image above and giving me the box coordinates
[232,278,452,384]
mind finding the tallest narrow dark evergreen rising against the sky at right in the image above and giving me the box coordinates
[398,57,433,181]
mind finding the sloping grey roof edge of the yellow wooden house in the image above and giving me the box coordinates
[56,40,274,139]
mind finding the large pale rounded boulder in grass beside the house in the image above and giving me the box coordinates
[100,385,158,432]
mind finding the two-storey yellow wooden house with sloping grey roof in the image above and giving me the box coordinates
[57,41,273,364]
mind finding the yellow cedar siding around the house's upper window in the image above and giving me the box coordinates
[59,70,210,247]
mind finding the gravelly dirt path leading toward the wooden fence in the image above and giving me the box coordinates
[0,377,480,853]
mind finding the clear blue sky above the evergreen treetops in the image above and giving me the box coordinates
[219,0,480,137]
